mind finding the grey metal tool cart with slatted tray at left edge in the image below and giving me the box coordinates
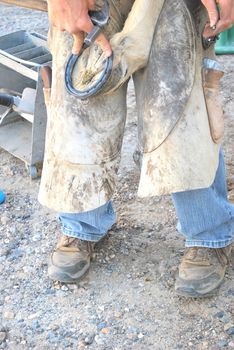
[0,31,52,178]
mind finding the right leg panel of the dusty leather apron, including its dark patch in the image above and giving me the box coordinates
[136,0,221,197]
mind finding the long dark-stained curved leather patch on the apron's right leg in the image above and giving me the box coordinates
[133,1,196,152]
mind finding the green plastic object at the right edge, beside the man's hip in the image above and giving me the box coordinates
[215,26,234,55]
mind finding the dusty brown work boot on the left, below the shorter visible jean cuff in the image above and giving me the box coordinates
[48,235,95,283]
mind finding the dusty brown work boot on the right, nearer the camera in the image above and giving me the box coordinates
[175,245,232,298]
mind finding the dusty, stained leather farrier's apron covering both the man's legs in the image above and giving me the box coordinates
[39,0,223,212]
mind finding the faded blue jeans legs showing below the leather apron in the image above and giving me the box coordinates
[59,152,234,248]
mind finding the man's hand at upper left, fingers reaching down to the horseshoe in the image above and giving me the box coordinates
[48,0,112,57]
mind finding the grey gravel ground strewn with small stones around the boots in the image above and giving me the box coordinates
[0,5,234,350]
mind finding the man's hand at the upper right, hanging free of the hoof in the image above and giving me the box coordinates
[201,0,234,38]
